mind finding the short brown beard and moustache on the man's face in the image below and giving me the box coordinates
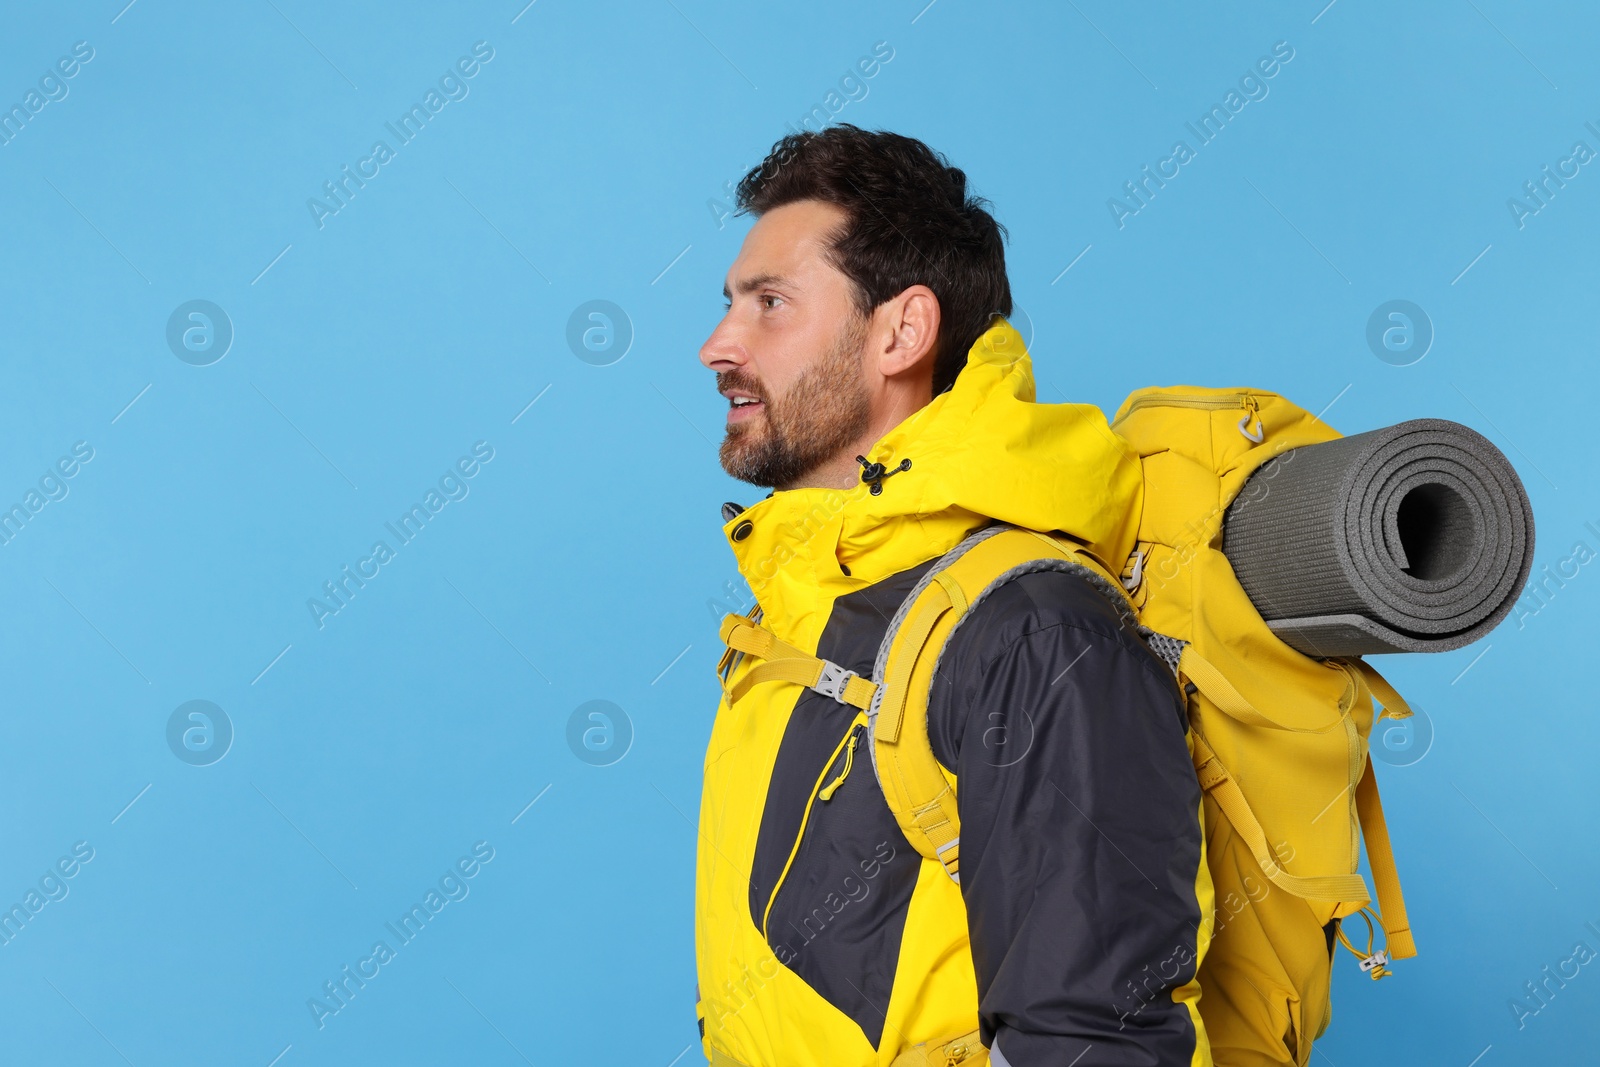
[717,318,872,488]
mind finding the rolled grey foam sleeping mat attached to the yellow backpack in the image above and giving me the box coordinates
[1222,419,1533,657]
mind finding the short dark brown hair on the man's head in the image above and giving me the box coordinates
[736,123,1011,395]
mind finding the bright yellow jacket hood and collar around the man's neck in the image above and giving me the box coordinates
[723,318,1142,648]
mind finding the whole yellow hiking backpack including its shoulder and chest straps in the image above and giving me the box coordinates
[722,387,1416,1065]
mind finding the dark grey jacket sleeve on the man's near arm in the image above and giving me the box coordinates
[930,579,1210,1067]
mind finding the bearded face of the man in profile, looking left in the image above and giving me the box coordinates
[699,200,870,490]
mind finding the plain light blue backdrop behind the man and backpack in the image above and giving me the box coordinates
[0,0,1600,1067]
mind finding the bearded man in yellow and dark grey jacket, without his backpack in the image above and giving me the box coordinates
[696,125,1211,1067]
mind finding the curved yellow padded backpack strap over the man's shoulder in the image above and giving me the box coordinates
[867,525,1133,881]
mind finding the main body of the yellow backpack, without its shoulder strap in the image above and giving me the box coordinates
[1112,389,1416,1064]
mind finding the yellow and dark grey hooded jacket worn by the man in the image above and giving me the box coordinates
[696,322,1210,1067]
